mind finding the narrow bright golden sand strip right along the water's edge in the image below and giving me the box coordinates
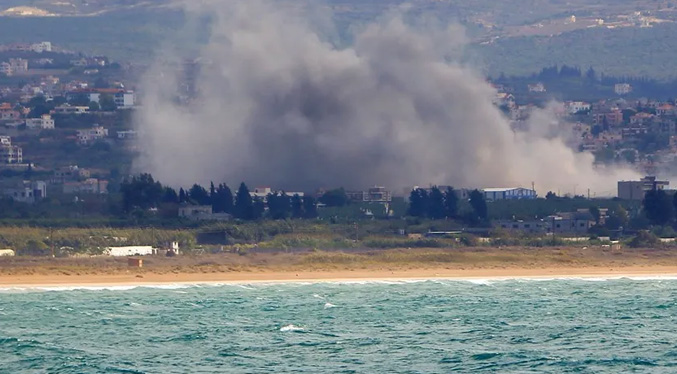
[0,266,677,289]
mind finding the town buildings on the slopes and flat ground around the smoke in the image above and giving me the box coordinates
[0,41,677,243]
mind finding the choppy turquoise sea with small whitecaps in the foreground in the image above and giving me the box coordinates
[0,279,677,374]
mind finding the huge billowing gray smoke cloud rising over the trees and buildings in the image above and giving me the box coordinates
[135,0,637,195]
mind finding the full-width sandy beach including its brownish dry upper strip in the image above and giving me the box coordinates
[0,248,677,288]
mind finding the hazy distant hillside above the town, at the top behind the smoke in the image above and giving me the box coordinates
[0,0,677,79]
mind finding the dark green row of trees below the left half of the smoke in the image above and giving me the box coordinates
[120,174,317,220]
